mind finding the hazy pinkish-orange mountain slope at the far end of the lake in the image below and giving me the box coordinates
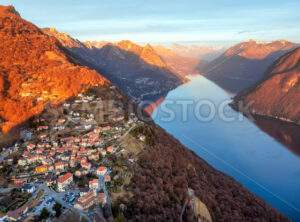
[154,45,200,76]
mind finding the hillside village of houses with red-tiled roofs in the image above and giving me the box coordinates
[0,90,145,221]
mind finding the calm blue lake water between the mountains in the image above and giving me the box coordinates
[152,76,300,221]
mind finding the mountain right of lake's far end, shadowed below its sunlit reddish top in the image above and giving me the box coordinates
[198,40,297,93]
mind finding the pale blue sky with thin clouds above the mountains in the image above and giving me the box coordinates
[0,0,300,46]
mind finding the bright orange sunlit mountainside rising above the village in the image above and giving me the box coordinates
[0,6,107,132]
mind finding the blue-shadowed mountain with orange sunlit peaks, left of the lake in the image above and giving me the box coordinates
[43,28,186,104]
